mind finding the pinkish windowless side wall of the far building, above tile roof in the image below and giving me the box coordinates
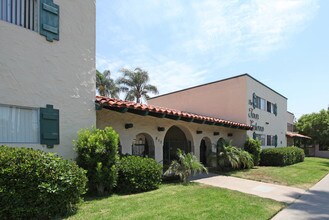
[148,76,247,123]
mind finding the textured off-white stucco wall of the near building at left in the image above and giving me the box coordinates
[0,0,96,158]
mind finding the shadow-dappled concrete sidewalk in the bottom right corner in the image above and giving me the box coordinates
[272,174,329,220]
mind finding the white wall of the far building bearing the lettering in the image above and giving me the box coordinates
[245,77,287,148]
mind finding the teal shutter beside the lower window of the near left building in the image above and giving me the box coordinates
[40,105,59,148]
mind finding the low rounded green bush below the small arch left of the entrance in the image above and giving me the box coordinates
[117,156,162,193]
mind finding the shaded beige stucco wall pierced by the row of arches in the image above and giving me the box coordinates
[96,109,246,162]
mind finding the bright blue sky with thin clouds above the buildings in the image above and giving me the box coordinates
[96,0,329,118]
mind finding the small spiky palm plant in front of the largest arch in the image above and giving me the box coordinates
[164,149,208,184]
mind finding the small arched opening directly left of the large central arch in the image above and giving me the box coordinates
[132,133,155,159]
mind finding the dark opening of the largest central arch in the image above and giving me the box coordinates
[163,126,192,166]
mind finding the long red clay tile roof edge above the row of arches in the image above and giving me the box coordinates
[95,96,252,130]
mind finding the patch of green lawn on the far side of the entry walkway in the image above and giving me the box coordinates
[227,157,329,189]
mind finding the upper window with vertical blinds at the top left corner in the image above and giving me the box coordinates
[0,0,39,31]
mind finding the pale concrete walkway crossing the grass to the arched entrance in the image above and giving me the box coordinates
[193,174,304,204]
